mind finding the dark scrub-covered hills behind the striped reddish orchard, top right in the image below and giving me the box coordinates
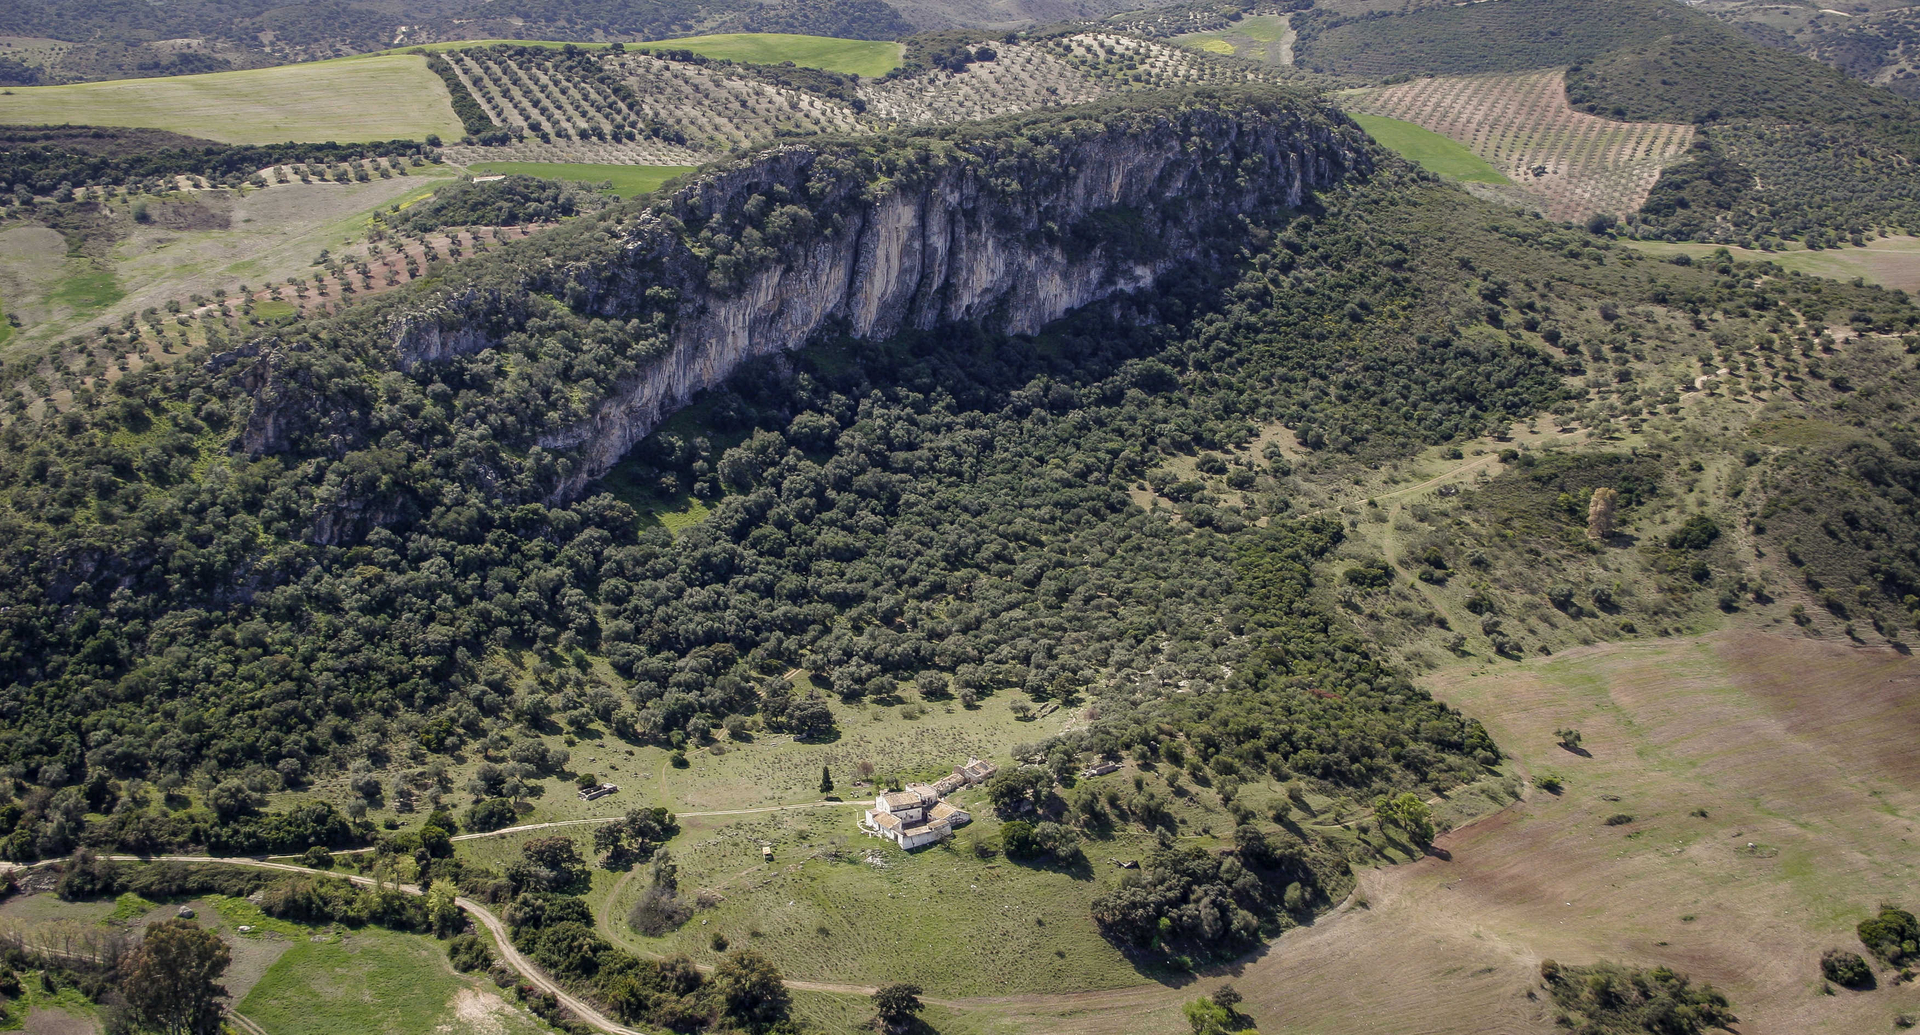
[1292,0,1920,248]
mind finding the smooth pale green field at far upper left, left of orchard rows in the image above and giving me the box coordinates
[0,54,463,144]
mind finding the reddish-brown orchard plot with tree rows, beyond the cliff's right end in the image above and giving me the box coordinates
[1346,69,1693,221]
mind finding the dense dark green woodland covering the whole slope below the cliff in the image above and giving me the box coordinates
[0,91,1914,906]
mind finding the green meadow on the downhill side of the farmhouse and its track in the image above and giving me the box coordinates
[603,810,1152,997]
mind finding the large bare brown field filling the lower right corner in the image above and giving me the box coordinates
[952,630,1920,1035]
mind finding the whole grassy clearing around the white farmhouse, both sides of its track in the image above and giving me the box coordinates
[435,675,1420,997]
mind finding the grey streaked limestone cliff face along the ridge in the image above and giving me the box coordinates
[392,94,1367,499]
